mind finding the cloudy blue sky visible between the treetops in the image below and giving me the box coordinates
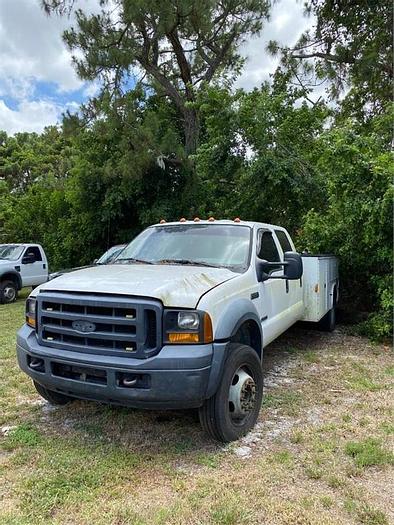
[0,0,312,135]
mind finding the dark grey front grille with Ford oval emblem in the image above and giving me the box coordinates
[37,291,162,358]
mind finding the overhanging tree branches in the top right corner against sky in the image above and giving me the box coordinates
[269,0,393,118]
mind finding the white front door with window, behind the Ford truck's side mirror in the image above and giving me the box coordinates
[257,229,290,345]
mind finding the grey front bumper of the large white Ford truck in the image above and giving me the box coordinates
[16,325,226,409]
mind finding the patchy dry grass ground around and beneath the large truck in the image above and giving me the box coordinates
[0,293,394,525]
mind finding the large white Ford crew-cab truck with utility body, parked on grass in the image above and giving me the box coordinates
[17,218,338,442]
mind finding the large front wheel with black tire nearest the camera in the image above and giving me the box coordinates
[199,343,263,443]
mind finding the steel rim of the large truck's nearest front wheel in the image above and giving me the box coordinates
[228,366,257,425]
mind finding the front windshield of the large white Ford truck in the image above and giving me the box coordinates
[115,224,251,271]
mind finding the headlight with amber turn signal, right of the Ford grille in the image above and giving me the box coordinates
[164,310,213,344]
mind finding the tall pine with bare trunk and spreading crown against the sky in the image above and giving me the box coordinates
[43,0,271,155]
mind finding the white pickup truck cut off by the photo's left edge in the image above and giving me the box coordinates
[0,244,48,304]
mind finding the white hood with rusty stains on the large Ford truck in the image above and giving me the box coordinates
[34,264,238,308]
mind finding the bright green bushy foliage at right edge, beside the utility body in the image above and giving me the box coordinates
[299,112,394,338]
